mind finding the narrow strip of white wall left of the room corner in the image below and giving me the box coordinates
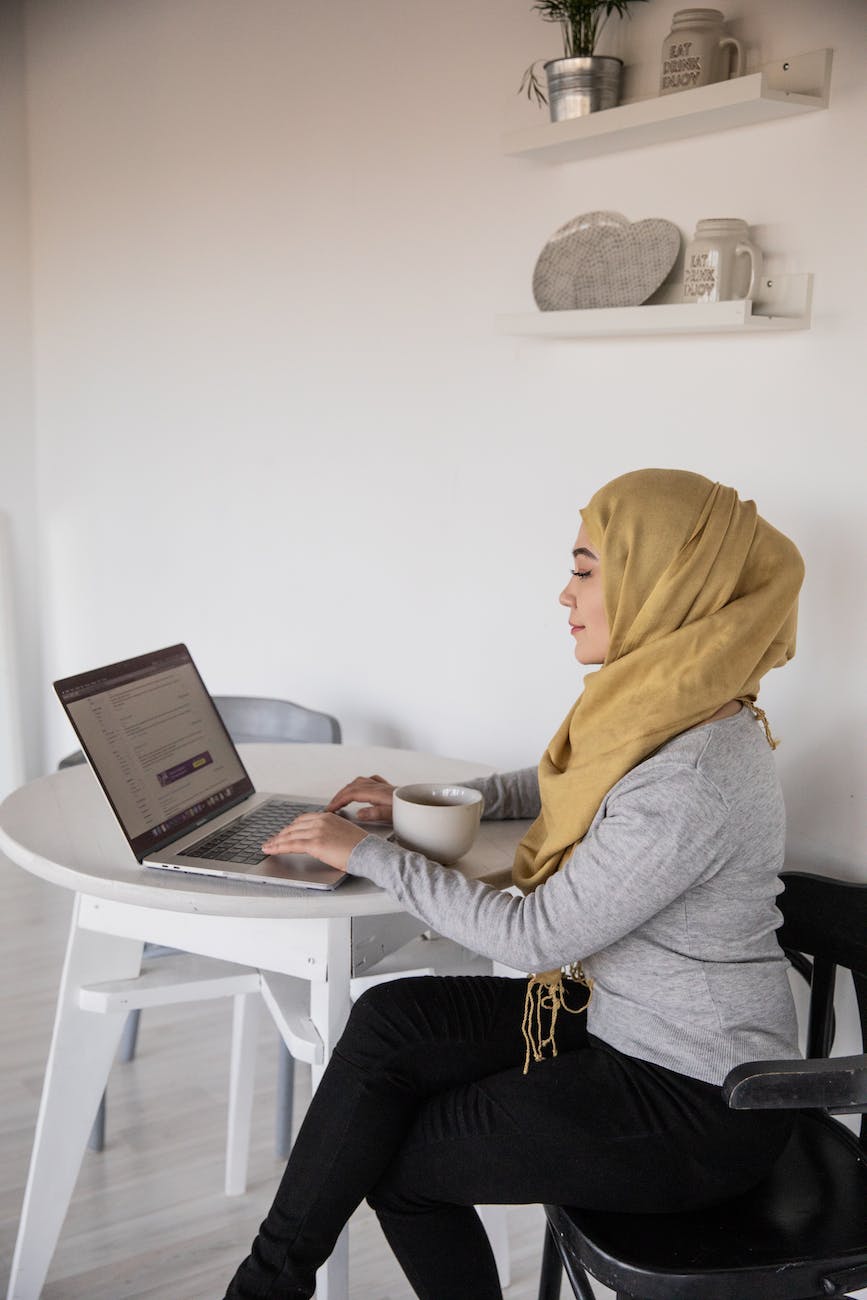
[0,0,42,798]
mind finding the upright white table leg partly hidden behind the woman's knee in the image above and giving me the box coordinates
[311,917,352,1300]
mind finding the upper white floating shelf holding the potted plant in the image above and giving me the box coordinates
[503,49,832,163]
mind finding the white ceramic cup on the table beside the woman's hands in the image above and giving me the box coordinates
[391,785,484,866]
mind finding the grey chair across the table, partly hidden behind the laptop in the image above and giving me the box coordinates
[57,696,342,1160]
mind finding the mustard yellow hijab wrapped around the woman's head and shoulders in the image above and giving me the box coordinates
[512,469,803,892]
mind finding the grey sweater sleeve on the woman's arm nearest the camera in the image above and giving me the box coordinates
[348,764,728,971]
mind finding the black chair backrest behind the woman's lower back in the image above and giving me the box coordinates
[777,871,867,1145]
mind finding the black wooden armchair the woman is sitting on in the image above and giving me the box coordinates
[539,872,867,1300]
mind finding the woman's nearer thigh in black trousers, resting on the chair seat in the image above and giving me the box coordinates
[368,1018,786,1214]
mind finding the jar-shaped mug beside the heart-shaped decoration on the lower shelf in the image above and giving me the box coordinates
[682,217,762,303]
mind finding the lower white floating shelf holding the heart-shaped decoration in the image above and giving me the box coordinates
[498,276,812,338]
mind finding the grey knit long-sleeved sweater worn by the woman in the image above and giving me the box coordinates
[348,709,798,1083]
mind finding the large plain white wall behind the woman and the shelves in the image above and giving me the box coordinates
[20,0,867,876]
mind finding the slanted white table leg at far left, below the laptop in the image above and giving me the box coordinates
[6,898,142,1300]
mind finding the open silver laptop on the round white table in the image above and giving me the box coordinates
[55,645,346,889]
